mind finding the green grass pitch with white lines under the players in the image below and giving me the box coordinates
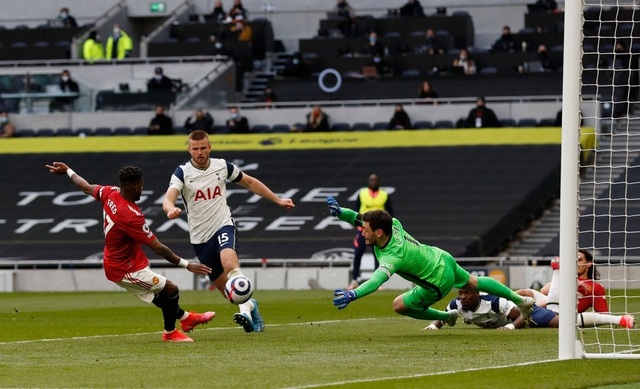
[0,290,640,389]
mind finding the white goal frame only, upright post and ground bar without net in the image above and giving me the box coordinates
[558,0,640,360]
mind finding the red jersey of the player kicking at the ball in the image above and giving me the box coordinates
[93,185,155,282]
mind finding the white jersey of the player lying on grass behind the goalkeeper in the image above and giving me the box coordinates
[447,293,517,328]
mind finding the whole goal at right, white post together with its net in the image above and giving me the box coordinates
[559,0,640,359]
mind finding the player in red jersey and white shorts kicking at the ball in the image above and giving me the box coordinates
[46,162,215,342]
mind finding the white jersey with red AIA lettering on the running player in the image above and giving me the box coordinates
[169,158,242,244]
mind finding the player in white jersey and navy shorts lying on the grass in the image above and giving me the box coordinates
[424,288,636,330]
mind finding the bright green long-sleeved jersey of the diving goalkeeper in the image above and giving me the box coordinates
[340,208,450,298]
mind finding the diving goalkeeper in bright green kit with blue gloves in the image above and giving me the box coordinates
[327,196,534,326]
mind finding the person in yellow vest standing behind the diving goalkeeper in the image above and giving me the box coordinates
[347,174,393,290]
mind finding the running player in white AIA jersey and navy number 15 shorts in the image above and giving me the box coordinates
[162,130,295,332]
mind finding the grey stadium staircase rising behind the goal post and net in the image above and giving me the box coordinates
[504,118,640,257]
